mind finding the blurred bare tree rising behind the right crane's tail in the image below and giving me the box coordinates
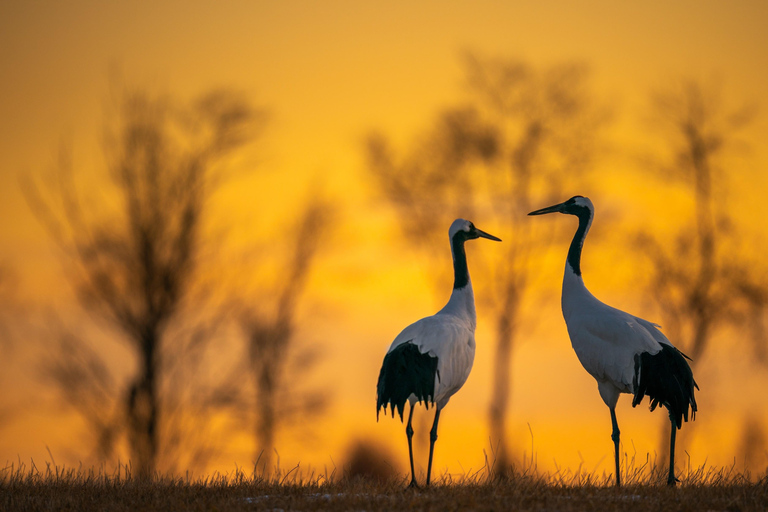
[636,81,768,460]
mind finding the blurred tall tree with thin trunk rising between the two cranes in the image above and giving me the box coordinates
[368,55,605,474]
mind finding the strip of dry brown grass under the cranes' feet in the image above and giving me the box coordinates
[0,464,768,511]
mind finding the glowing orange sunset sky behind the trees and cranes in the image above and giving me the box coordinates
[0,0,768,480]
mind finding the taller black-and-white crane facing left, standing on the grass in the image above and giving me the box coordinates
[528,196,699,486]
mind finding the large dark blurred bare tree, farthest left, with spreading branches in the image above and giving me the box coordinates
[26,83,260,478]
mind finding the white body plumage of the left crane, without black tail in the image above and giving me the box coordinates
[387,281,477,409]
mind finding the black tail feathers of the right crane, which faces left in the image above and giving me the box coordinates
[632,344,699,428]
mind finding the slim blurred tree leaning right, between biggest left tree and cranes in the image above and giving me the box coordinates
[237,198,333,471]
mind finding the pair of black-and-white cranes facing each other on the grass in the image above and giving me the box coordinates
[376,196,698,486]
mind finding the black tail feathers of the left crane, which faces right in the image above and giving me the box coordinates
[376,342,437,421]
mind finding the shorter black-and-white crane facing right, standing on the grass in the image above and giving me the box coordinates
[376,219,501,487]
